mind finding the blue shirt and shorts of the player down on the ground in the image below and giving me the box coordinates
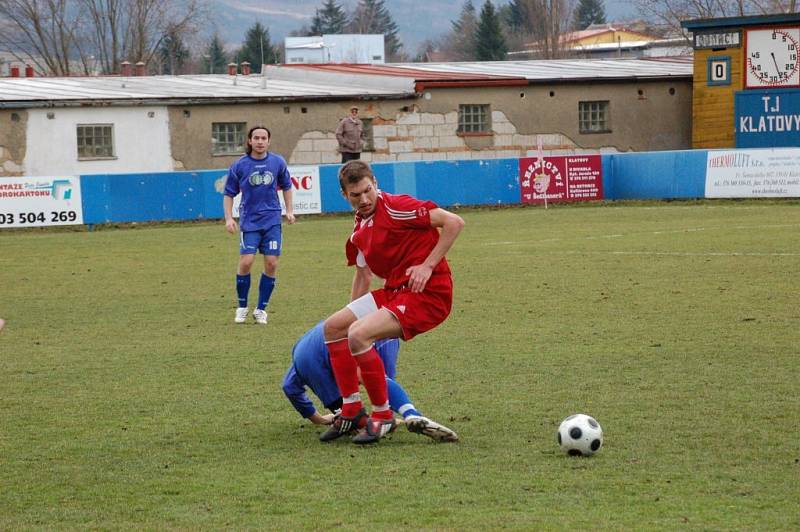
[283,322,400,417]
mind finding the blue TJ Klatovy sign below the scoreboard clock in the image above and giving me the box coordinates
[734,89,800,148]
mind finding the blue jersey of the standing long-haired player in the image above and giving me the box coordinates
[225,152,292,231]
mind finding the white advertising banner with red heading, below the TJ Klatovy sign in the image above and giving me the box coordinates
[705,148,800,198]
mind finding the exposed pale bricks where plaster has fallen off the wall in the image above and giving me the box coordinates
[289,111,616,164]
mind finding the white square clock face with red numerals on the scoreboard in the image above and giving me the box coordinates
[745,28,800,88]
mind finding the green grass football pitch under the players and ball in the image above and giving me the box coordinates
[0,201,800,530]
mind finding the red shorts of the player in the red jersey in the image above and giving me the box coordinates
[371,274,453,340]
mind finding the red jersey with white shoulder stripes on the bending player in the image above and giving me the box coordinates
[345,192,450,289]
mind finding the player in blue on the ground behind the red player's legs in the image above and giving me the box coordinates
[283,322,458,441]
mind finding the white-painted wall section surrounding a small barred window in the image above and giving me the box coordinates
[23,107,173,176]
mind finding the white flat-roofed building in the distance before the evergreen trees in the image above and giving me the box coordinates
[284,34,386,65]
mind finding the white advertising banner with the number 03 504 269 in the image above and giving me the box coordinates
[0,176,83,229]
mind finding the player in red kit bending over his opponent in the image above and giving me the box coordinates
[320,160,464,443]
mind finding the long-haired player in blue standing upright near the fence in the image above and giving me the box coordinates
[222,126,294,325]
